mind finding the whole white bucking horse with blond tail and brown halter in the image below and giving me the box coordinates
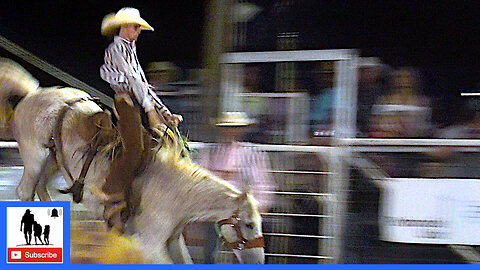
[0,59,265,263]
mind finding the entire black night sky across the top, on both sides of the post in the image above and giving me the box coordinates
[0,0,480,97]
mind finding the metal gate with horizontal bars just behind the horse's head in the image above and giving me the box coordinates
[188,143,341,264]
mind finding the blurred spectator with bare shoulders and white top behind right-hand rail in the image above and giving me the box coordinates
[370,68,432,177]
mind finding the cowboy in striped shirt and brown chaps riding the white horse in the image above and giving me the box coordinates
[100,8,183,232]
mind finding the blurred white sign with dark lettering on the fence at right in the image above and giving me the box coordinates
[379,178,480,245]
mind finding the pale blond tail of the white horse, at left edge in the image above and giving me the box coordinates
[0,58,39,128]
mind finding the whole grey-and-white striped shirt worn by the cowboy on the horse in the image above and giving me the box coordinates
[100,36,168,113]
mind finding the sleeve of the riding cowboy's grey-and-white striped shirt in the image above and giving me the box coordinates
[100,43,154,112]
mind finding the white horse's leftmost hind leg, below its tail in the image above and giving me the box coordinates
[16,145,51,201]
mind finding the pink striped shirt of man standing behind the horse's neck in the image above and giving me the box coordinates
[198,142,276,212]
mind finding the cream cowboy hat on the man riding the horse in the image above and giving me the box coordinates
[102,8,153,36]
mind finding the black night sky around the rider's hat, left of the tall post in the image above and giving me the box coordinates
[0,0,204,91]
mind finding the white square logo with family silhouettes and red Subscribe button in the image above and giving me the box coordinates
[6,207,64,263]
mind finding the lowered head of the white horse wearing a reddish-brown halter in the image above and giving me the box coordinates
[217,193,265,264]
